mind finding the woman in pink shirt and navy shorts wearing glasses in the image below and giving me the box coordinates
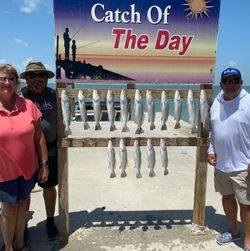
[0,64,48,251]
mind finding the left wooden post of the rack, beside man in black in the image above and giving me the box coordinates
[56,83,69,238]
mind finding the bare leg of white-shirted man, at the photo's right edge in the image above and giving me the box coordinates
[240,204,250,249]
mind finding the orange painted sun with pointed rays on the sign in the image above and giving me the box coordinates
[183,0,213,20]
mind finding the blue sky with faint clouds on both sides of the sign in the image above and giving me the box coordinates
[0,0,250,85]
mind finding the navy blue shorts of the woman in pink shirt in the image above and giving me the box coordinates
[0,174,36,205]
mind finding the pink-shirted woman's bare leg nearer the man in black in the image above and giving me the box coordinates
[15,198,29,250]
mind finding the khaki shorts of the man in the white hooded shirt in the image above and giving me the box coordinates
[214,168,250,205]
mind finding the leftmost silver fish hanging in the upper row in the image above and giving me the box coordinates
[61,90,72,137]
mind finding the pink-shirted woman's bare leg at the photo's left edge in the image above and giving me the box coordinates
[0,202,18,251]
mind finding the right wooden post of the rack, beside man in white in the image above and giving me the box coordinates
[192,85,212,226]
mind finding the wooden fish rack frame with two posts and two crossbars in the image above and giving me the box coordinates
[56,82,213,238]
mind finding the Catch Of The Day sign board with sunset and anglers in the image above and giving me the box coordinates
[54,0,220,83]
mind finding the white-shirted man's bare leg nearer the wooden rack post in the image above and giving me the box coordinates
[222,194,238,235]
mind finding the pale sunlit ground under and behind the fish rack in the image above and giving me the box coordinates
[0,114,245,251]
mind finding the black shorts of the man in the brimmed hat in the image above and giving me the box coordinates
[38,154,58,188]
